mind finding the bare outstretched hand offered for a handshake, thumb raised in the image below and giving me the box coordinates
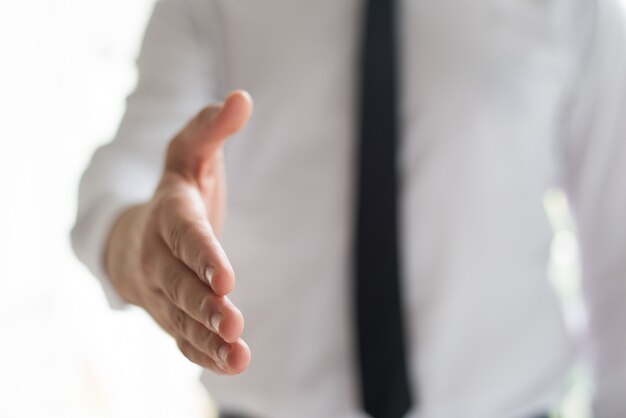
[105,90,252,375]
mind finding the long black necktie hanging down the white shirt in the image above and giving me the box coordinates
[355,0,411,418]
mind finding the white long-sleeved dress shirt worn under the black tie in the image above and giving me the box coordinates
[73,0,626,418]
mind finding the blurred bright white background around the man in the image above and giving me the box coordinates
[0,0,588,418]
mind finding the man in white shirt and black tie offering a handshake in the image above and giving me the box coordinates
[73,0,626,418]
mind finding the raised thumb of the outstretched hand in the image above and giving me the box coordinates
[165,90,252,180]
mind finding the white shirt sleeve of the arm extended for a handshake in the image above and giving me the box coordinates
[71,0,218,308]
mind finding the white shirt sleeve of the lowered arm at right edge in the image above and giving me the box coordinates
[565,0,626,418]
